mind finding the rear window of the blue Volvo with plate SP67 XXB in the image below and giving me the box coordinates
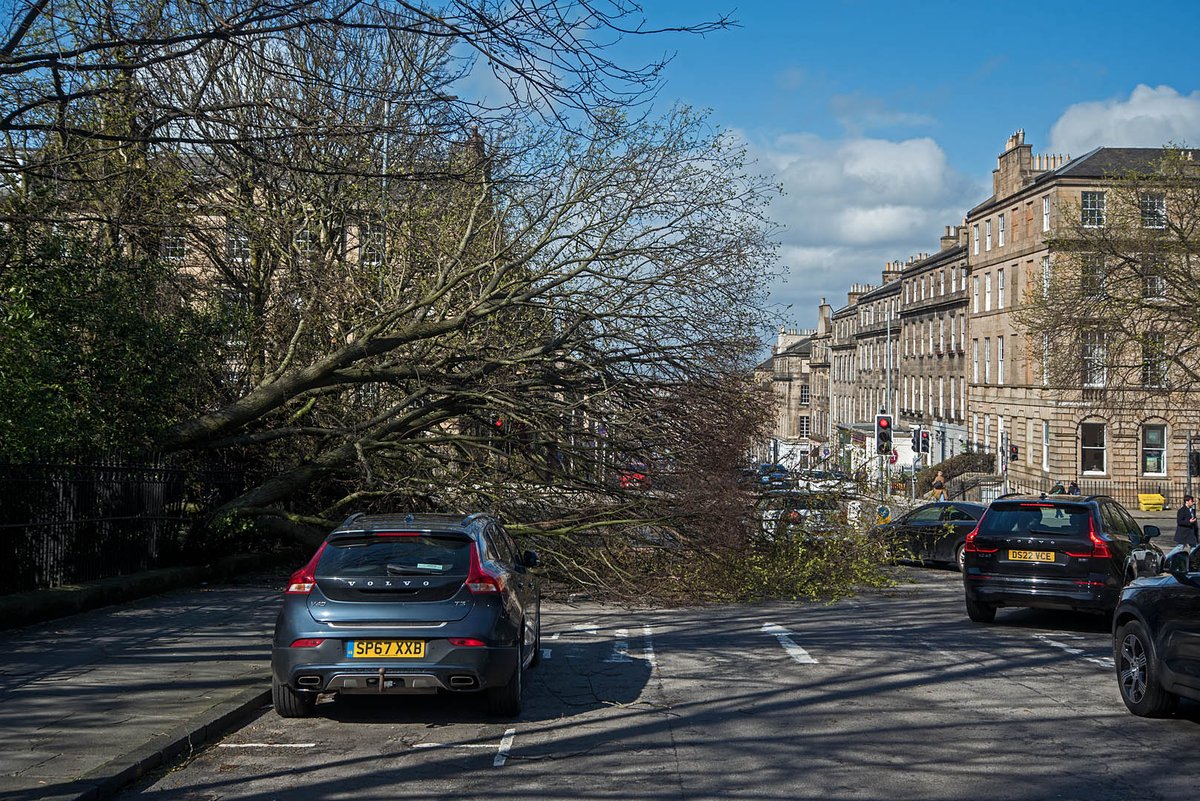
[317,535,470,578]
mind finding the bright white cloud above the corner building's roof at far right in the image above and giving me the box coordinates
[1049,84,1200,156]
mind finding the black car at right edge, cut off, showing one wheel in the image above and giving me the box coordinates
[1112,548,1200,717]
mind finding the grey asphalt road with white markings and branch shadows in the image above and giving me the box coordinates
[119,568,1200,801]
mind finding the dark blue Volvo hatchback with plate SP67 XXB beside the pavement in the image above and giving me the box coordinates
[271,513,541,717]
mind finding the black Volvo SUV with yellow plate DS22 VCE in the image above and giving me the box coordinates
[962,495,1163,622]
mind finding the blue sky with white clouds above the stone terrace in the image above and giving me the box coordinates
[622,0,1200,338]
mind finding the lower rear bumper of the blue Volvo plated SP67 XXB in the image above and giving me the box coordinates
[271,639,520,694]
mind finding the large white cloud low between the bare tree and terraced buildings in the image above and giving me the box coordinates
[751,133,990,327]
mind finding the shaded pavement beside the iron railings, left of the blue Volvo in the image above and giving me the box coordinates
[0,565,295,801]
